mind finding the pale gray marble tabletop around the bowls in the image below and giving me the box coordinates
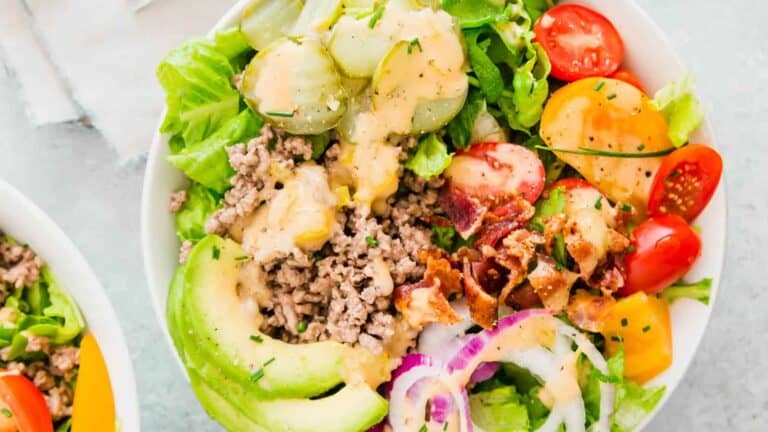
[0,0,768,431]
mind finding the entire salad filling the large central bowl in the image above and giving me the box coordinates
[157,0,722,432]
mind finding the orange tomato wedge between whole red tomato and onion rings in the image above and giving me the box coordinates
[601,292,672,384]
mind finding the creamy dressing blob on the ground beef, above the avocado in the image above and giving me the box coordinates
[243,163,336,263]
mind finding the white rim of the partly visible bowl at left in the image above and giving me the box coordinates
[0,180,140,432]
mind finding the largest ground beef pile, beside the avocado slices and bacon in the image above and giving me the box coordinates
[255,167,442,353]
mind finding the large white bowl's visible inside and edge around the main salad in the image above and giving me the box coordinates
[141,0,727,430]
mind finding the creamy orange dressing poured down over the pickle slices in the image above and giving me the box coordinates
[332,0,468,207]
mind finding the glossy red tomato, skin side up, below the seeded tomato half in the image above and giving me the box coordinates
[619,214,701,296]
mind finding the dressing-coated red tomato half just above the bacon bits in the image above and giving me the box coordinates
[445,143,546,203]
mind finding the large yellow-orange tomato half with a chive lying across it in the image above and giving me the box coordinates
[541,78,672,215]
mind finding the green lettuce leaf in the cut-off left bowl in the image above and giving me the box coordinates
[40,267,85,345]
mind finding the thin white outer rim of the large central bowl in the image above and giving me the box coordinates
[141,0,728,431]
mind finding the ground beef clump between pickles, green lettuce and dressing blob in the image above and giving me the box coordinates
[205,126,312,234]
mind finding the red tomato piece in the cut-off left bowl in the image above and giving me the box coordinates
[0,372,53,432]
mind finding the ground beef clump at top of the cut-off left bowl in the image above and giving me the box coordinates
[0,232,45,301]
